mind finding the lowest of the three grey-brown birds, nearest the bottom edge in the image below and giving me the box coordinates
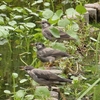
[22,66,72,89]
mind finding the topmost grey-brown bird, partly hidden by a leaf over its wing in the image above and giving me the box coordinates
[41,20,75,42]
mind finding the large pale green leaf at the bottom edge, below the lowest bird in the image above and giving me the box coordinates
[34,86,50,99]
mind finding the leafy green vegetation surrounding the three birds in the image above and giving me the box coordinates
[0,0,100,100]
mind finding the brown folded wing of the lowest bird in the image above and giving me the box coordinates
[33,69,60,81]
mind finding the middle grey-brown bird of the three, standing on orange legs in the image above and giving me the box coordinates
[35,42,71,68]
